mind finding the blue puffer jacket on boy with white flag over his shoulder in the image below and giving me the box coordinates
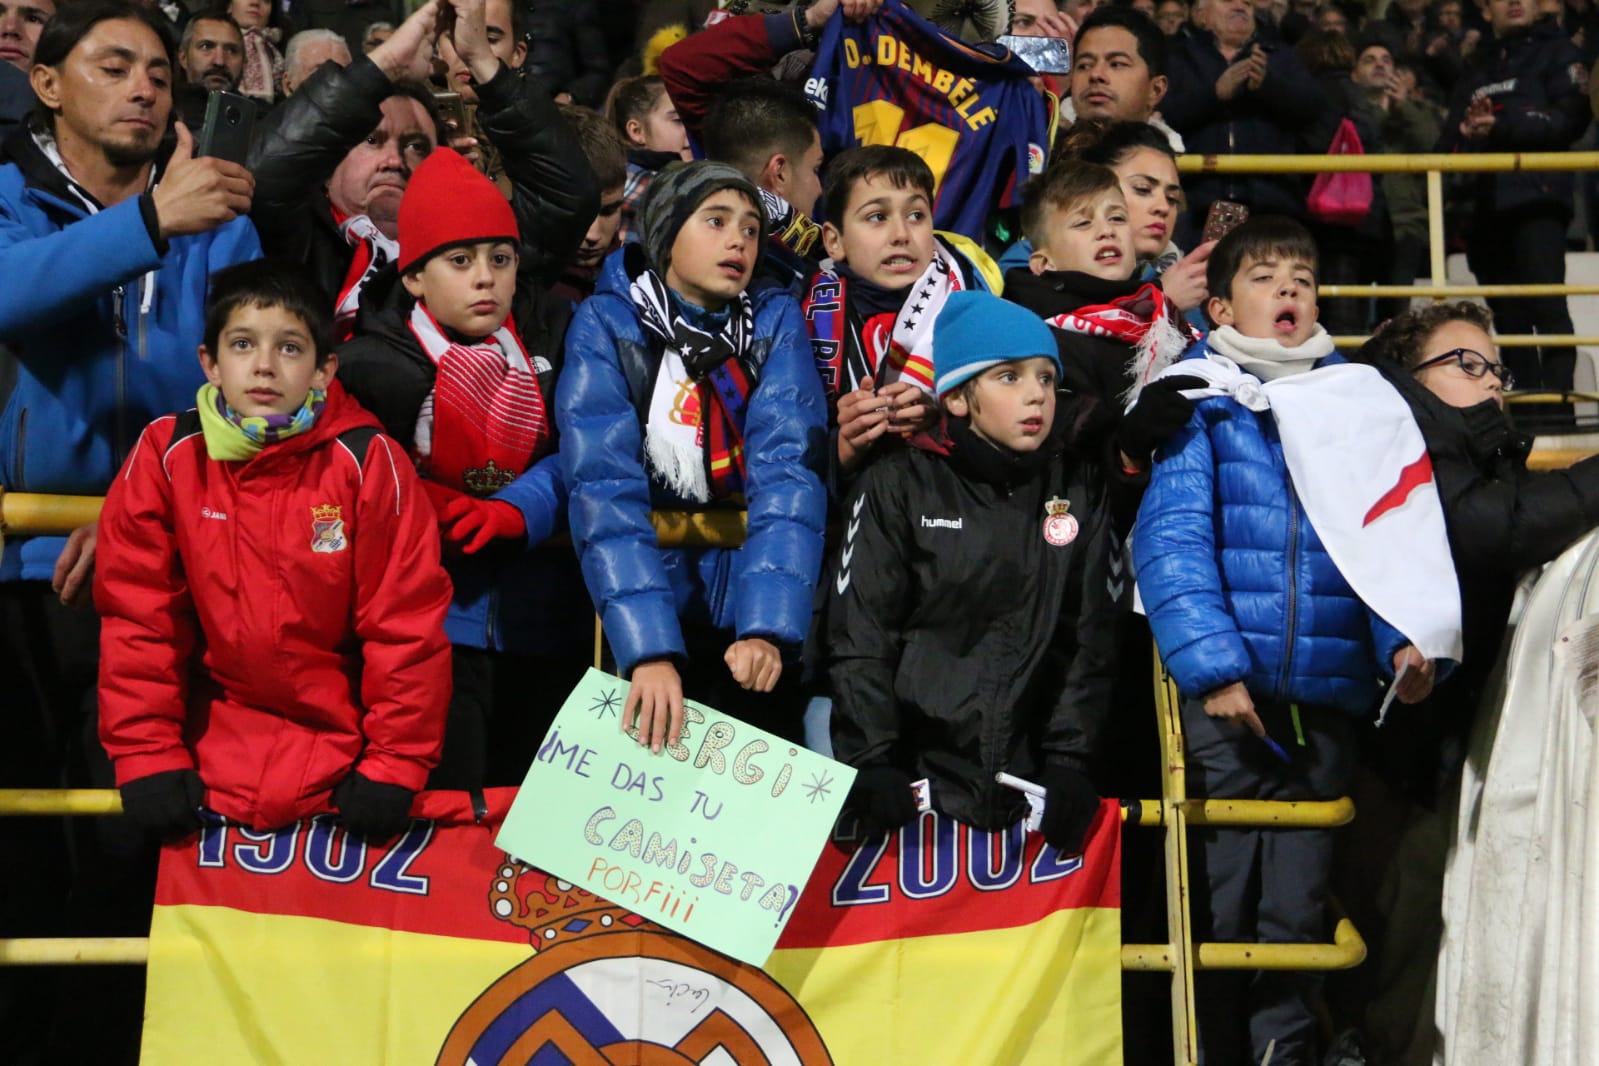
[1132,344,1406,714]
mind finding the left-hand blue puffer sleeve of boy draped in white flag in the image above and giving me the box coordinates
[1132,401,1249,697]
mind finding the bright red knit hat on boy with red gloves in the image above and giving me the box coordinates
[400,149,520,273]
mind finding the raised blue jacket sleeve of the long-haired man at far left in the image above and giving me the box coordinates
[0,197,161,342]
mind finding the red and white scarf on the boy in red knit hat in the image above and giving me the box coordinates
[411,302,550,497]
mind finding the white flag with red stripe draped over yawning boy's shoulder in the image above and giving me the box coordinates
[1161,354,1460,662]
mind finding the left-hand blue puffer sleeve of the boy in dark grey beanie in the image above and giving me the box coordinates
[555,296,688,676]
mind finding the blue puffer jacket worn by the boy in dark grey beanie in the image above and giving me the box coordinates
[555,246,827,676]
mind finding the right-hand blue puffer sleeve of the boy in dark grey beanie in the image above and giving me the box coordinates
[732,296,827,644]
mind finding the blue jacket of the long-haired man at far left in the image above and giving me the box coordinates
[0,126,261,580]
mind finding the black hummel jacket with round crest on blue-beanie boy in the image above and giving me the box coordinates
[827,422,1116,829]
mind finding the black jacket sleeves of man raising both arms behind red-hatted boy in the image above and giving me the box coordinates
[249,56,600,294]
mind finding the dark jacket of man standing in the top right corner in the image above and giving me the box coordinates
[1438,19,1593,217]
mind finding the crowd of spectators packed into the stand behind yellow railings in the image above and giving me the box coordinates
[0,0,1599,1063]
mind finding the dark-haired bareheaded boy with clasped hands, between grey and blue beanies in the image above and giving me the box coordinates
[804,145,998,475]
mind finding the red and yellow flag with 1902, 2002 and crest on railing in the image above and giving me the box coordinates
[141,788,1121,1066]
